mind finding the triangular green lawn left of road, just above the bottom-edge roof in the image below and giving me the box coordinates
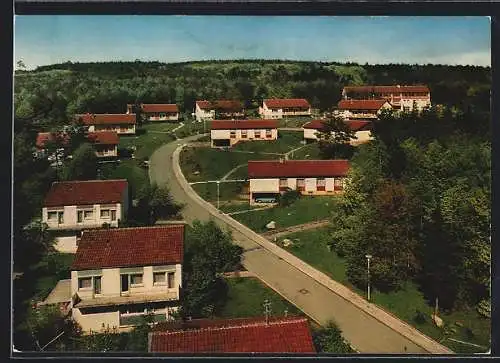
[217,277,304,318]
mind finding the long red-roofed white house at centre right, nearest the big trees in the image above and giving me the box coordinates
[248,160,349,205]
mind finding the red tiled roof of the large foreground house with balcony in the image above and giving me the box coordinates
[71,224,184,270]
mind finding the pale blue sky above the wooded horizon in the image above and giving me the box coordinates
[14,15,491,69]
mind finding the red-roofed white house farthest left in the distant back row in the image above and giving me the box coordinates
[75,113,136,135]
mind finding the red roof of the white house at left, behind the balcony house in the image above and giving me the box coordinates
[43,179,128,207]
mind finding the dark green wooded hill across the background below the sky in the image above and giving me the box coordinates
[15,60,491,129]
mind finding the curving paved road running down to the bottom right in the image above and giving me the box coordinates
[149,136,448,354]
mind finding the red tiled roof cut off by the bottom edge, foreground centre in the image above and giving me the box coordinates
[149,317,316,353]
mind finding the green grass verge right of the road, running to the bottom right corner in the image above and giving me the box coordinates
[284,229,491,353]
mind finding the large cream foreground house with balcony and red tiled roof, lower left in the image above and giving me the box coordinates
[71,224,184,333]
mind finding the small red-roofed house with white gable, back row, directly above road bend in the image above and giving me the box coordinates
[194,100,245,122]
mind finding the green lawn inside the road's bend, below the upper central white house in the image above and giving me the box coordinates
[180,147,276,182]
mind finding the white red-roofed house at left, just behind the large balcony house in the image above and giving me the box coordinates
[42,179,129,253]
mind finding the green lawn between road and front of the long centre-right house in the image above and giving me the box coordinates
[233,196,337,233]
